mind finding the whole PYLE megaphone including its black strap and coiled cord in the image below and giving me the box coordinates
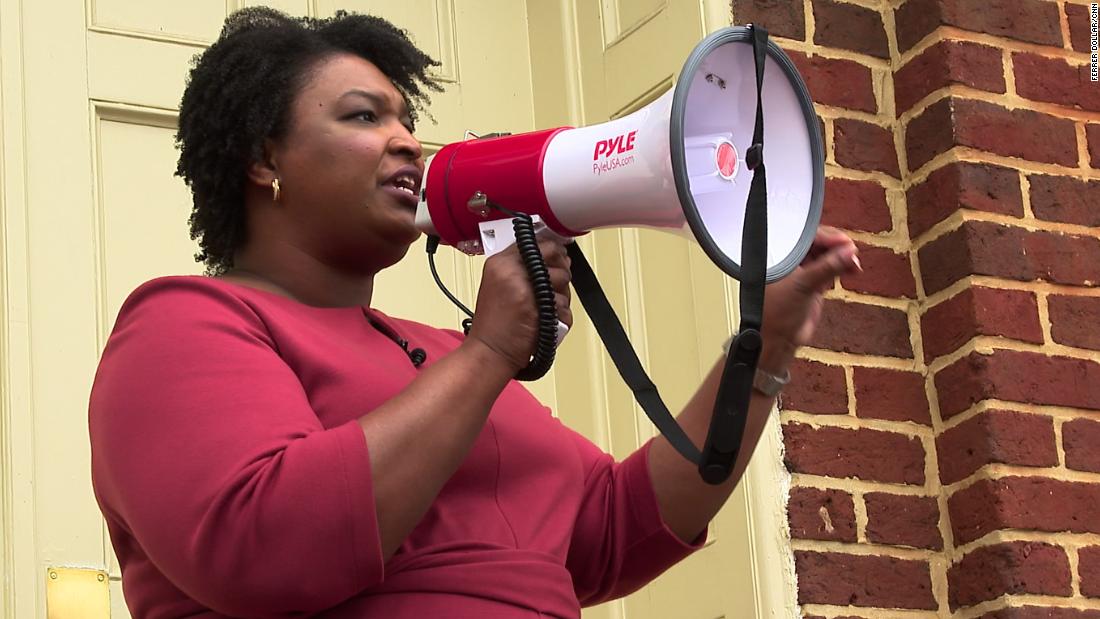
[416,25,825,484]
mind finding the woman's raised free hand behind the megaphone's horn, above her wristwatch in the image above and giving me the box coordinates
[760,226,862,373]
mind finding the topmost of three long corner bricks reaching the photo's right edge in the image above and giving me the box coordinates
[917,221,1100,295]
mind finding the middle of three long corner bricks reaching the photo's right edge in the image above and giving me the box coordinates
[935,350,1100,419]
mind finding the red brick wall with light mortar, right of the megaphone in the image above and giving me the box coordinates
[733,0,1100,619]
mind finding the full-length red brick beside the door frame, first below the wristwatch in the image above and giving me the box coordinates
[783,423,924,485]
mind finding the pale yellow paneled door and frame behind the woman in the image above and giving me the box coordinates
[0,0,792,619]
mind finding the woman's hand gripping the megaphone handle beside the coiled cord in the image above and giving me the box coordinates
[466,237,573,373]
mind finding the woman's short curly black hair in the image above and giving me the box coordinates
[176,7,442,275]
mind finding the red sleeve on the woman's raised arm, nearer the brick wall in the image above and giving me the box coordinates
[567,432,706,606]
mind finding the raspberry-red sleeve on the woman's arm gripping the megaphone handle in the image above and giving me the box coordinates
[89,286,383,617]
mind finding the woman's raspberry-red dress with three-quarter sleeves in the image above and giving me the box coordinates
[89,277,702,619]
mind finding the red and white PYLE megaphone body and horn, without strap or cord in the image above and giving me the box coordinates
[416,27,825,281]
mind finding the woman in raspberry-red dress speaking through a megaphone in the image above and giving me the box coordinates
[90,9,858,618]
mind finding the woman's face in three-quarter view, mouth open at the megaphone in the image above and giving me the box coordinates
[271,54,424,274]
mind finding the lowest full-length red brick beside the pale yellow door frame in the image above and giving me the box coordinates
[794,551,937,610]
